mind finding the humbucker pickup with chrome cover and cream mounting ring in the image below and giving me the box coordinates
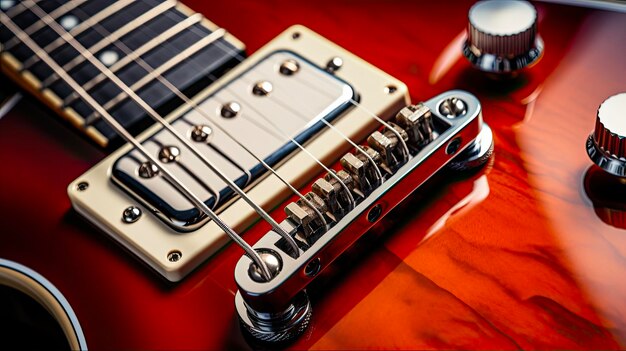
[68,26,409,281]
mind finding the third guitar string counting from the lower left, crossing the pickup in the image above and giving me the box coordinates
[62,4,329,229]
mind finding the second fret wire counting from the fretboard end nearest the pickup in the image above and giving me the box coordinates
[63,13,202,106]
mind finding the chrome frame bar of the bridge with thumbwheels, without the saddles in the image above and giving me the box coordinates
[235,90,493,341]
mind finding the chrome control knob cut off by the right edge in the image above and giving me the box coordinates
[587,93,626,177]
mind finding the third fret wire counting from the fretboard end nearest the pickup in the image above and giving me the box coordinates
[41,1,176,88]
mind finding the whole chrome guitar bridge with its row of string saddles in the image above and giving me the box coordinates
[235,91,492,341]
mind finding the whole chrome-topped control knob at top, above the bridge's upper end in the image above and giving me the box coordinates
[463,0,543,74]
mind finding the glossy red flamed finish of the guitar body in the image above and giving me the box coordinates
[0,0,626,349]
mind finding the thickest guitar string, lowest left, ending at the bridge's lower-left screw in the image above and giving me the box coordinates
[0,8,272,280]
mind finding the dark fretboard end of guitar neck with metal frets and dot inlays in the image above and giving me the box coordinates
[0,0,244,147]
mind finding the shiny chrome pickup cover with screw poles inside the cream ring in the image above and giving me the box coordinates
[112,51,356,231]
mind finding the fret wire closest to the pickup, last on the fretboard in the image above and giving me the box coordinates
[85,28,226,124]
